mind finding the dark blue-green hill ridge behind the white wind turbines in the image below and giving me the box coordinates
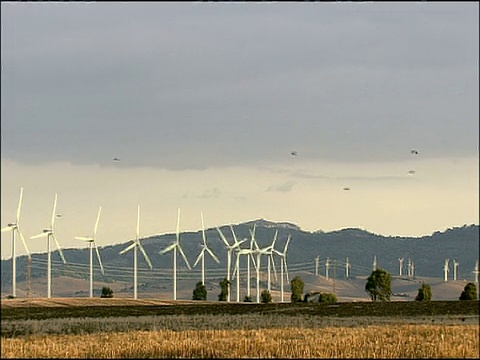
[1,219,479,296]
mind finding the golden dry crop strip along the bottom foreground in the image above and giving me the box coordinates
[1,324,480,358]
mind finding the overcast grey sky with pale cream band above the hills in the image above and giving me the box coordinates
[1,2,479,259]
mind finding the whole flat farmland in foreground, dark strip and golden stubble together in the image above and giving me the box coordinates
[1,299,479,358]
